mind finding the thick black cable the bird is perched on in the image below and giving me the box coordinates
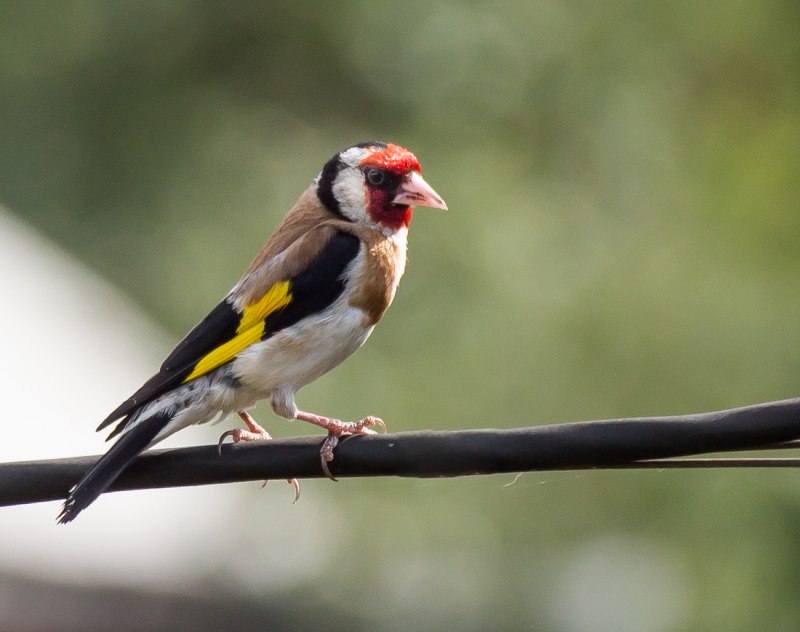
[0,399,800,506]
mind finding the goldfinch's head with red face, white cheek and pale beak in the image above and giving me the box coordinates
[316,141,447,233]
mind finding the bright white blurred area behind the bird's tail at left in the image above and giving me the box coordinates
[0,207,337,591]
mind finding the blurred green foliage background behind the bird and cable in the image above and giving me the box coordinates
[0,0,800,632]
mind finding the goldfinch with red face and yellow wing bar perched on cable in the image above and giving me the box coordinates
[58,141,447,523]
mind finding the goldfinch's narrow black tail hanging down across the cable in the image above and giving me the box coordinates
[58,413,172,524]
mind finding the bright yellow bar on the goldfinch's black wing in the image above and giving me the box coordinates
[183,281,292,383]
